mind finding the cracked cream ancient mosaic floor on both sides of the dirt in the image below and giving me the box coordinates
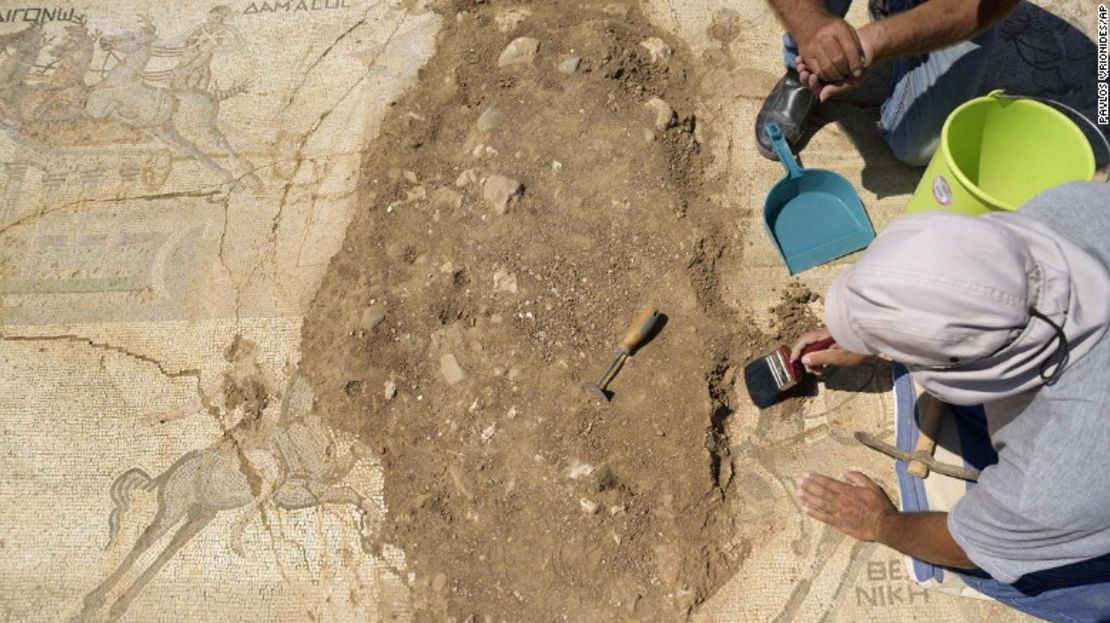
[0,0,1094,623]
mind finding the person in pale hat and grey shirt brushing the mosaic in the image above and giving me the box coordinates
[794,182,1110,621]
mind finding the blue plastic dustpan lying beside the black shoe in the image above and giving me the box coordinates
[764,121,875,274]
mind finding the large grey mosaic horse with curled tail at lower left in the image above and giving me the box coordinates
[74,374,377,621]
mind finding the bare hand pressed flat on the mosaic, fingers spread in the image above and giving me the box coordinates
[797,470,898,541]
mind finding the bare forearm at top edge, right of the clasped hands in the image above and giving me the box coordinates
[864,0,1019,62]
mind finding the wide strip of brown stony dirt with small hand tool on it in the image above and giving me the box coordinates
[301,0,810,622]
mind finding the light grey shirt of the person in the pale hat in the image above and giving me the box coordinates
[948,183,1110,583]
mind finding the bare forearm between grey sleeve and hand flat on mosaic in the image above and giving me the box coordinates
[877,512,976,569]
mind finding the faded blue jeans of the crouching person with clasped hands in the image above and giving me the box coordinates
[783,0,998,167]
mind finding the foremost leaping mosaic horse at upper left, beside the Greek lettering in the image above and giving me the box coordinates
[84,16,261,189]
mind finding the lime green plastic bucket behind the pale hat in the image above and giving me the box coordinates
[906,91,1110,214]
